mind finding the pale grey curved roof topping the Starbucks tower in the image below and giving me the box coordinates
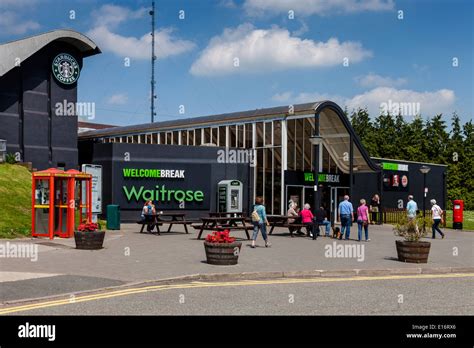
[0,29,101,76]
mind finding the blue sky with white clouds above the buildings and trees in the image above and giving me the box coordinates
[0,0,474,125]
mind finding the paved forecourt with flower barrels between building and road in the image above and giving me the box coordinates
[0,224,474,302]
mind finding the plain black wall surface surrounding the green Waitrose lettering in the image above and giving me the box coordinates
[79,142,253,221]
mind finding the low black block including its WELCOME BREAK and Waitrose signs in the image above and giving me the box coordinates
[80,142,253,221]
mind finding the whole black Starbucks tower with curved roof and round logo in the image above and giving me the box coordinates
[0,30,100,169]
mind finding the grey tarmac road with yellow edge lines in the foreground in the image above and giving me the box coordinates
[0,273,474,315]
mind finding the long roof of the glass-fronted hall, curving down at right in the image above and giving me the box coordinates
[79,100,380,173]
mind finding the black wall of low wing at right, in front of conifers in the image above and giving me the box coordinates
[351,159,446,210]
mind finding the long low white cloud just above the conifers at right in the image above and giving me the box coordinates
[272,87,456,117]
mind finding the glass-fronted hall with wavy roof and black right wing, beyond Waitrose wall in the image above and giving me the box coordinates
[79,101,446,221]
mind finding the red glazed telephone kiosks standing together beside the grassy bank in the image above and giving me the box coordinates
[31,168,92,239]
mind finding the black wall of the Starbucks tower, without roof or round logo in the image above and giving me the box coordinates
[0,41,82,169]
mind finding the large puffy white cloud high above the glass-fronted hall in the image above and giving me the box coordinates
[190,23,372,75]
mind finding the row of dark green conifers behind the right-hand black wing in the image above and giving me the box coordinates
[351,109,474,210]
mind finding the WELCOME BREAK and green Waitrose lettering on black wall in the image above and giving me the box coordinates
[122,168,209,208]
